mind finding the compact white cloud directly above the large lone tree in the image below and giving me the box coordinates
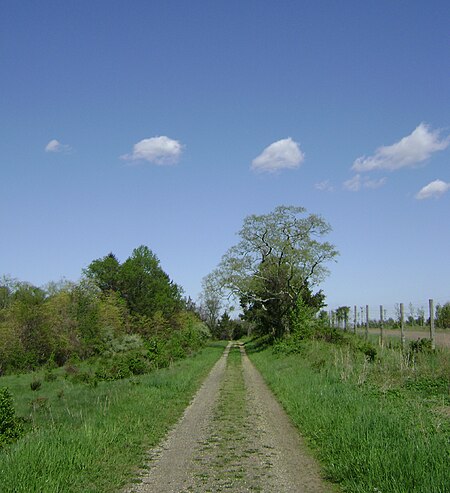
[251,137,305,173]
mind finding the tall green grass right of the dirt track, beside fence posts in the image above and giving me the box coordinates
[250,341,450,493]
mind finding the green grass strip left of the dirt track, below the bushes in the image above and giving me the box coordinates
[0,343,224,493]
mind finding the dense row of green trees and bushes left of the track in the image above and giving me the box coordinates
[0,246,208,374]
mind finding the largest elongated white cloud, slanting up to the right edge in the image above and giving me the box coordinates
[352,123,450,172]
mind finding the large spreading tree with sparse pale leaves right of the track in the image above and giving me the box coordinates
[211,206,338,337]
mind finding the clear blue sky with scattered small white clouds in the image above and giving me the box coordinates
[0,0,450,314]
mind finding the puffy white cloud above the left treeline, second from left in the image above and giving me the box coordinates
[121,135,183,165]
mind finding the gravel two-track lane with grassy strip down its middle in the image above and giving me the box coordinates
[127,344,333,493]
